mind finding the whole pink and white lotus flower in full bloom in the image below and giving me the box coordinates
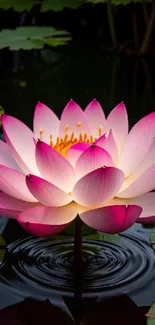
[0,100,155,236]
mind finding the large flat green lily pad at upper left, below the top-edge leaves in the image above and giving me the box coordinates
[0,26,71,50]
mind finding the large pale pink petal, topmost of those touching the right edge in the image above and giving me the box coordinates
[118,112,155,177]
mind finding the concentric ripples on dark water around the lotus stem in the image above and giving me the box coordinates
[0,234,155,297]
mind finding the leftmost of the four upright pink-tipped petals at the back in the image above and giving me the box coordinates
[33,102,60,144]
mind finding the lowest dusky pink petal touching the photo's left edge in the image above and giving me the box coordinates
[0,193,37,218]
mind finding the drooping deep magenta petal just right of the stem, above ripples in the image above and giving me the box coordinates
[80,205,142,234]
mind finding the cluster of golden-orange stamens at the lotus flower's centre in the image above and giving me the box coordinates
[40,122,102,158]
